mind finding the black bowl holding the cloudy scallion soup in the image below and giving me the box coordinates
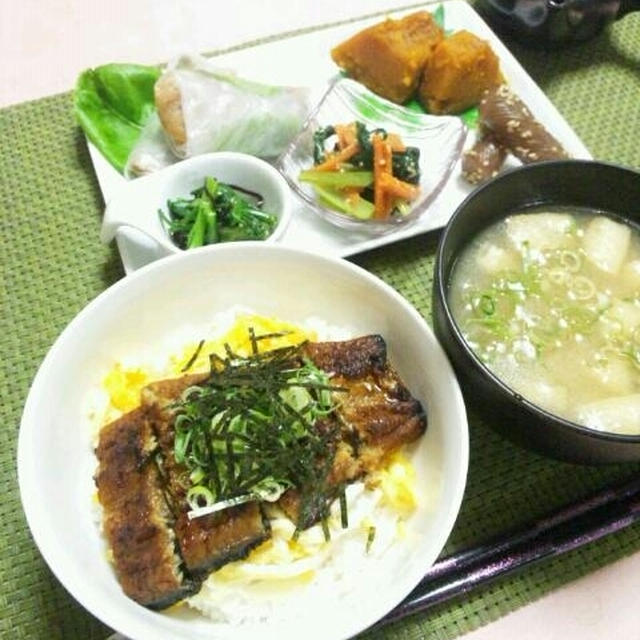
[433,160,640,464]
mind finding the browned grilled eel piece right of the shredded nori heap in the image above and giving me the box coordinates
[279,335,427,528]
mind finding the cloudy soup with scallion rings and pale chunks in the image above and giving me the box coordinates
[449,205,640,434]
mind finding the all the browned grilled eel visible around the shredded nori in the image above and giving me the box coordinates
[96,335,426,608]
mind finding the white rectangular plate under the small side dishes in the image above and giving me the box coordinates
[89,0,591,273]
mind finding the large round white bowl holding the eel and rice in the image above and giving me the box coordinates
[18,242,468,640]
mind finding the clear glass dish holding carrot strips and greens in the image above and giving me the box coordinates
[277,77,466,234]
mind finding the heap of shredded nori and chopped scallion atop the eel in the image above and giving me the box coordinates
[173,329,345,535]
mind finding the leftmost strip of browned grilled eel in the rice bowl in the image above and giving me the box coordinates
[95,407,199,609]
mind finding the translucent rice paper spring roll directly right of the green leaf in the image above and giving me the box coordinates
[154,56,309,158]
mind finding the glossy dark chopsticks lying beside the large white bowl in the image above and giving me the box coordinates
[376,475,640,626]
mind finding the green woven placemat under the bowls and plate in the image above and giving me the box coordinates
[0,5,640,640]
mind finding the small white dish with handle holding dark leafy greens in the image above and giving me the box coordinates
[100,152,291,255]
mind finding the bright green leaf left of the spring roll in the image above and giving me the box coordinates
[74,64,161,172]
